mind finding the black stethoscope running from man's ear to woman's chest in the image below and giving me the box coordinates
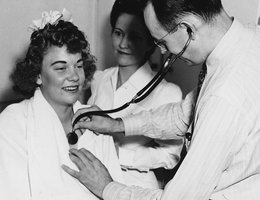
[67,27,192,145]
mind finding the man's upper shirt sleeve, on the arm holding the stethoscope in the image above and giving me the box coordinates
[122,91,195,140]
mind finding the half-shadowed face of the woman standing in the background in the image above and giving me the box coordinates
[112,13,153,67]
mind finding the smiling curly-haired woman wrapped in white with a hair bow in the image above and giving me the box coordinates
[0,10,121,200]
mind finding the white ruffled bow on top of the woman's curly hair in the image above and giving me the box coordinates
[29,8,73,31]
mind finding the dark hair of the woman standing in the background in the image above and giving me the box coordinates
[110,0,155,57]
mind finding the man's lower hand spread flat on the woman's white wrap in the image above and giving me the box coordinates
[62,149,113,198]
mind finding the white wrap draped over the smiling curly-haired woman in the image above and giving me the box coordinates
[0,90,122,200]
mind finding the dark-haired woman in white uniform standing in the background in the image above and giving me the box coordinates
[88,0,182,188]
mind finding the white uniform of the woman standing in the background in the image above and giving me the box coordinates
[88,63,182,188]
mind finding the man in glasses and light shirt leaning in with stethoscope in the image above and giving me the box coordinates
[64,0,260,200]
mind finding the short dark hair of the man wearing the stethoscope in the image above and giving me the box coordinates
[149,0,223,31]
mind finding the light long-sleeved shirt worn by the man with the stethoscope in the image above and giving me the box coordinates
[104,20,260,200]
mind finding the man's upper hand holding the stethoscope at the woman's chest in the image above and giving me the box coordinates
[72,106,125,136]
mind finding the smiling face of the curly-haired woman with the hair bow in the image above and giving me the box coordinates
[37,46,85,106]
